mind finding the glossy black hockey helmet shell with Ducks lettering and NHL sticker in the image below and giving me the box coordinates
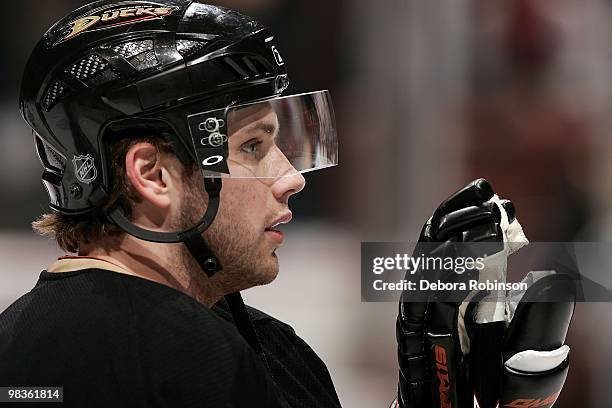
[20,0,288,214]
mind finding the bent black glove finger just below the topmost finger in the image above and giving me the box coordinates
[435,202,501,241]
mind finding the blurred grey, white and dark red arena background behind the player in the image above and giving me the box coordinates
[0,0,612,408]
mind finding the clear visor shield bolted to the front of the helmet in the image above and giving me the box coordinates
[188,91,338,179]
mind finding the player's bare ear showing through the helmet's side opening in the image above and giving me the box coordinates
[125,142,173,208]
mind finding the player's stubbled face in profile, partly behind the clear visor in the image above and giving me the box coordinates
[183,104,305,289]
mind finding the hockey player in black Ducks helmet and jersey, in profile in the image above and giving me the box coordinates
[0,0,567,407]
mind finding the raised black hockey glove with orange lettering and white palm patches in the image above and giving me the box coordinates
[396,179,575,408]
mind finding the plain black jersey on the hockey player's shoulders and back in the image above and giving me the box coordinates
[0,269,340,407]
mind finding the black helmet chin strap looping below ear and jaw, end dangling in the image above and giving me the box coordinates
[107,177,263,355]
